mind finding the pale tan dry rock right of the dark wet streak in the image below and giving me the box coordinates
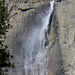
[56,0,75,75]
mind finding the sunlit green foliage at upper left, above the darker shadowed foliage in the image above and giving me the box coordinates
[0,0,9,35]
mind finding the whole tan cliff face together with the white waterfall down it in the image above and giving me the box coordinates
[0,0,75,75]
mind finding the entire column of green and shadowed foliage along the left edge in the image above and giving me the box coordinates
[0,0,14,75]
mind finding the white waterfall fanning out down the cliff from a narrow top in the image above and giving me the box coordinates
[22,1,54,75]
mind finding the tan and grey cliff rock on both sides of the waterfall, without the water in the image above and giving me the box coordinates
[5,0,75,75]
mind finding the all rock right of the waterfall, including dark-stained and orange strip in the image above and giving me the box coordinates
[49,0,75,75]
